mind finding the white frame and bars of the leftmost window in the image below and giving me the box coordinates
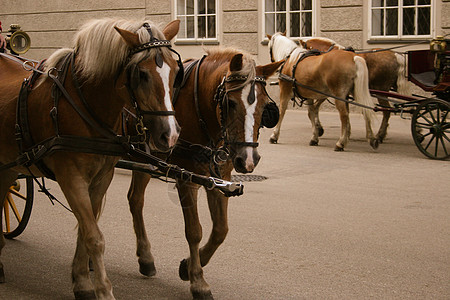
[172,0,220,44]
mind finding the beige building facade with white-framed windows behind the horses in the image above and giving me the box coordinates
[0,0,450,64]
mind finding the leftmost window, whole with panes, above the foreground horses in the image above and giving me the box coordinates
[176,0,217,40]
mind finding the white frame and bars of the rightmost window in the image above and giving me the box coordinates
[367,0,436,41]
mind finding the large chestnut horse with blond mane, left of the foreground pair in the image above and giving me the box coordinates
[0,18,181,299]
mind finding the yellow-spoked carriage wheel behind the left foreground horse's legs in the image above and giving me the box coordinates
[2,177,34,239]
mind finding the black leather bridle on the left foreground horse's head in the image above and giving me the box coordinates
[125,23,184,140]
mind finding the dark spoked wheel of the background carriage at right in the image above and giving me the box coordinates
[411,99,450,159]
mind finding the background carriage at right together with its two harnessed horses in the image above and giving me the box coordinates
[268,33,450,159]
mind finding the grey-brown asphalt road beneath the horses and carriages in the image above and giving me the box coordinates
[0,110,450,300]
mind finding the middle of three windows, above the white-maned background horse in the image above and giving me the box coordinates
[264,0,315,37]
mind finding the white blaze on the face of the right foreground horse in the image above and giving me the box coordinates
[241,84,258,171]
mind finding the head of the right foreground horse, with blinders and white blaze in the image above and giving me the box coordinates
[219,53,283,173]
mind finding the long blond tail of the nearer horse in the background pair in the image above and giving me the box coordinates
[353,55,375,121]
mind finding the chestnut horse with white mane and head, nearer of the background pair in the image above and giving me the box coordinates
[267,32,378,151]
